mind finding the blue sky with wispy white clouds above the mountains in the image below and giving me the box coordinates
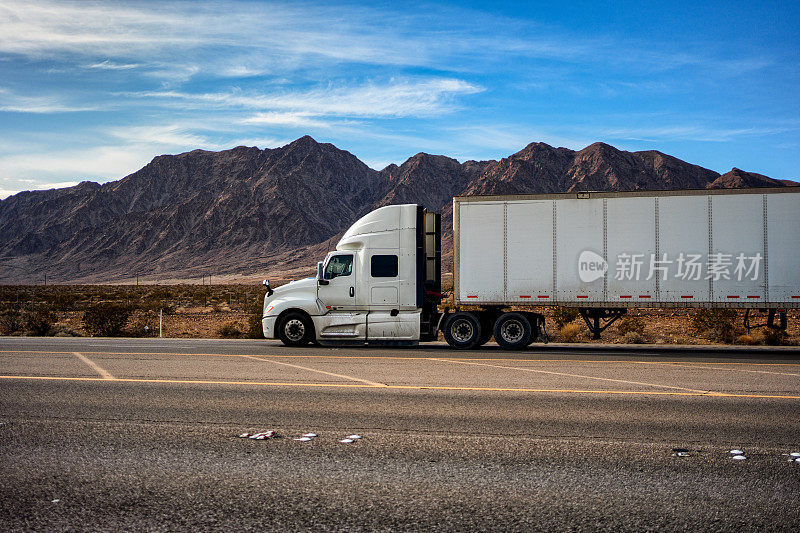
[0,0,800,198]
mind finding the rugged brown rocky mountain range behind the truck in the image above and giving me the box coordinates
[0,136,793,283]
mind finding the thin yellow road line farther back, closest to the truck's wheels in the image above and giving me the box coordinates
[0,350,800,367]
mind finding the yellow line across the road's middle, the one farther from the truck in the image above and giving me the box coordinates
[0,375,800,400]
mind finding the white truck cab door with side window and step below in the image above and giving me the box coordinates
[315,253,367,340]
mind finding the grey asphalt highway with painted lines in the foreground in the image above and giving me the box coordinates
[0,337,800,531]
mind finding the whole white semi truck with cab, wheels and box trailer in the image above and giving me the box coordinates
[262,187,800,349]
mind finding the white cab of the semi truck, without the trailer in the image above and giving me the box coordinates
[262,204,441,346]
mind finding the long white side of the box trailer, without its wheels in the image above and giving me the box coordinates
[453,188,800,308]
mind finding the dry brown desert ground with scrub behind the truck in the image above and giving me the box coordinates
[0,283,800,345]
